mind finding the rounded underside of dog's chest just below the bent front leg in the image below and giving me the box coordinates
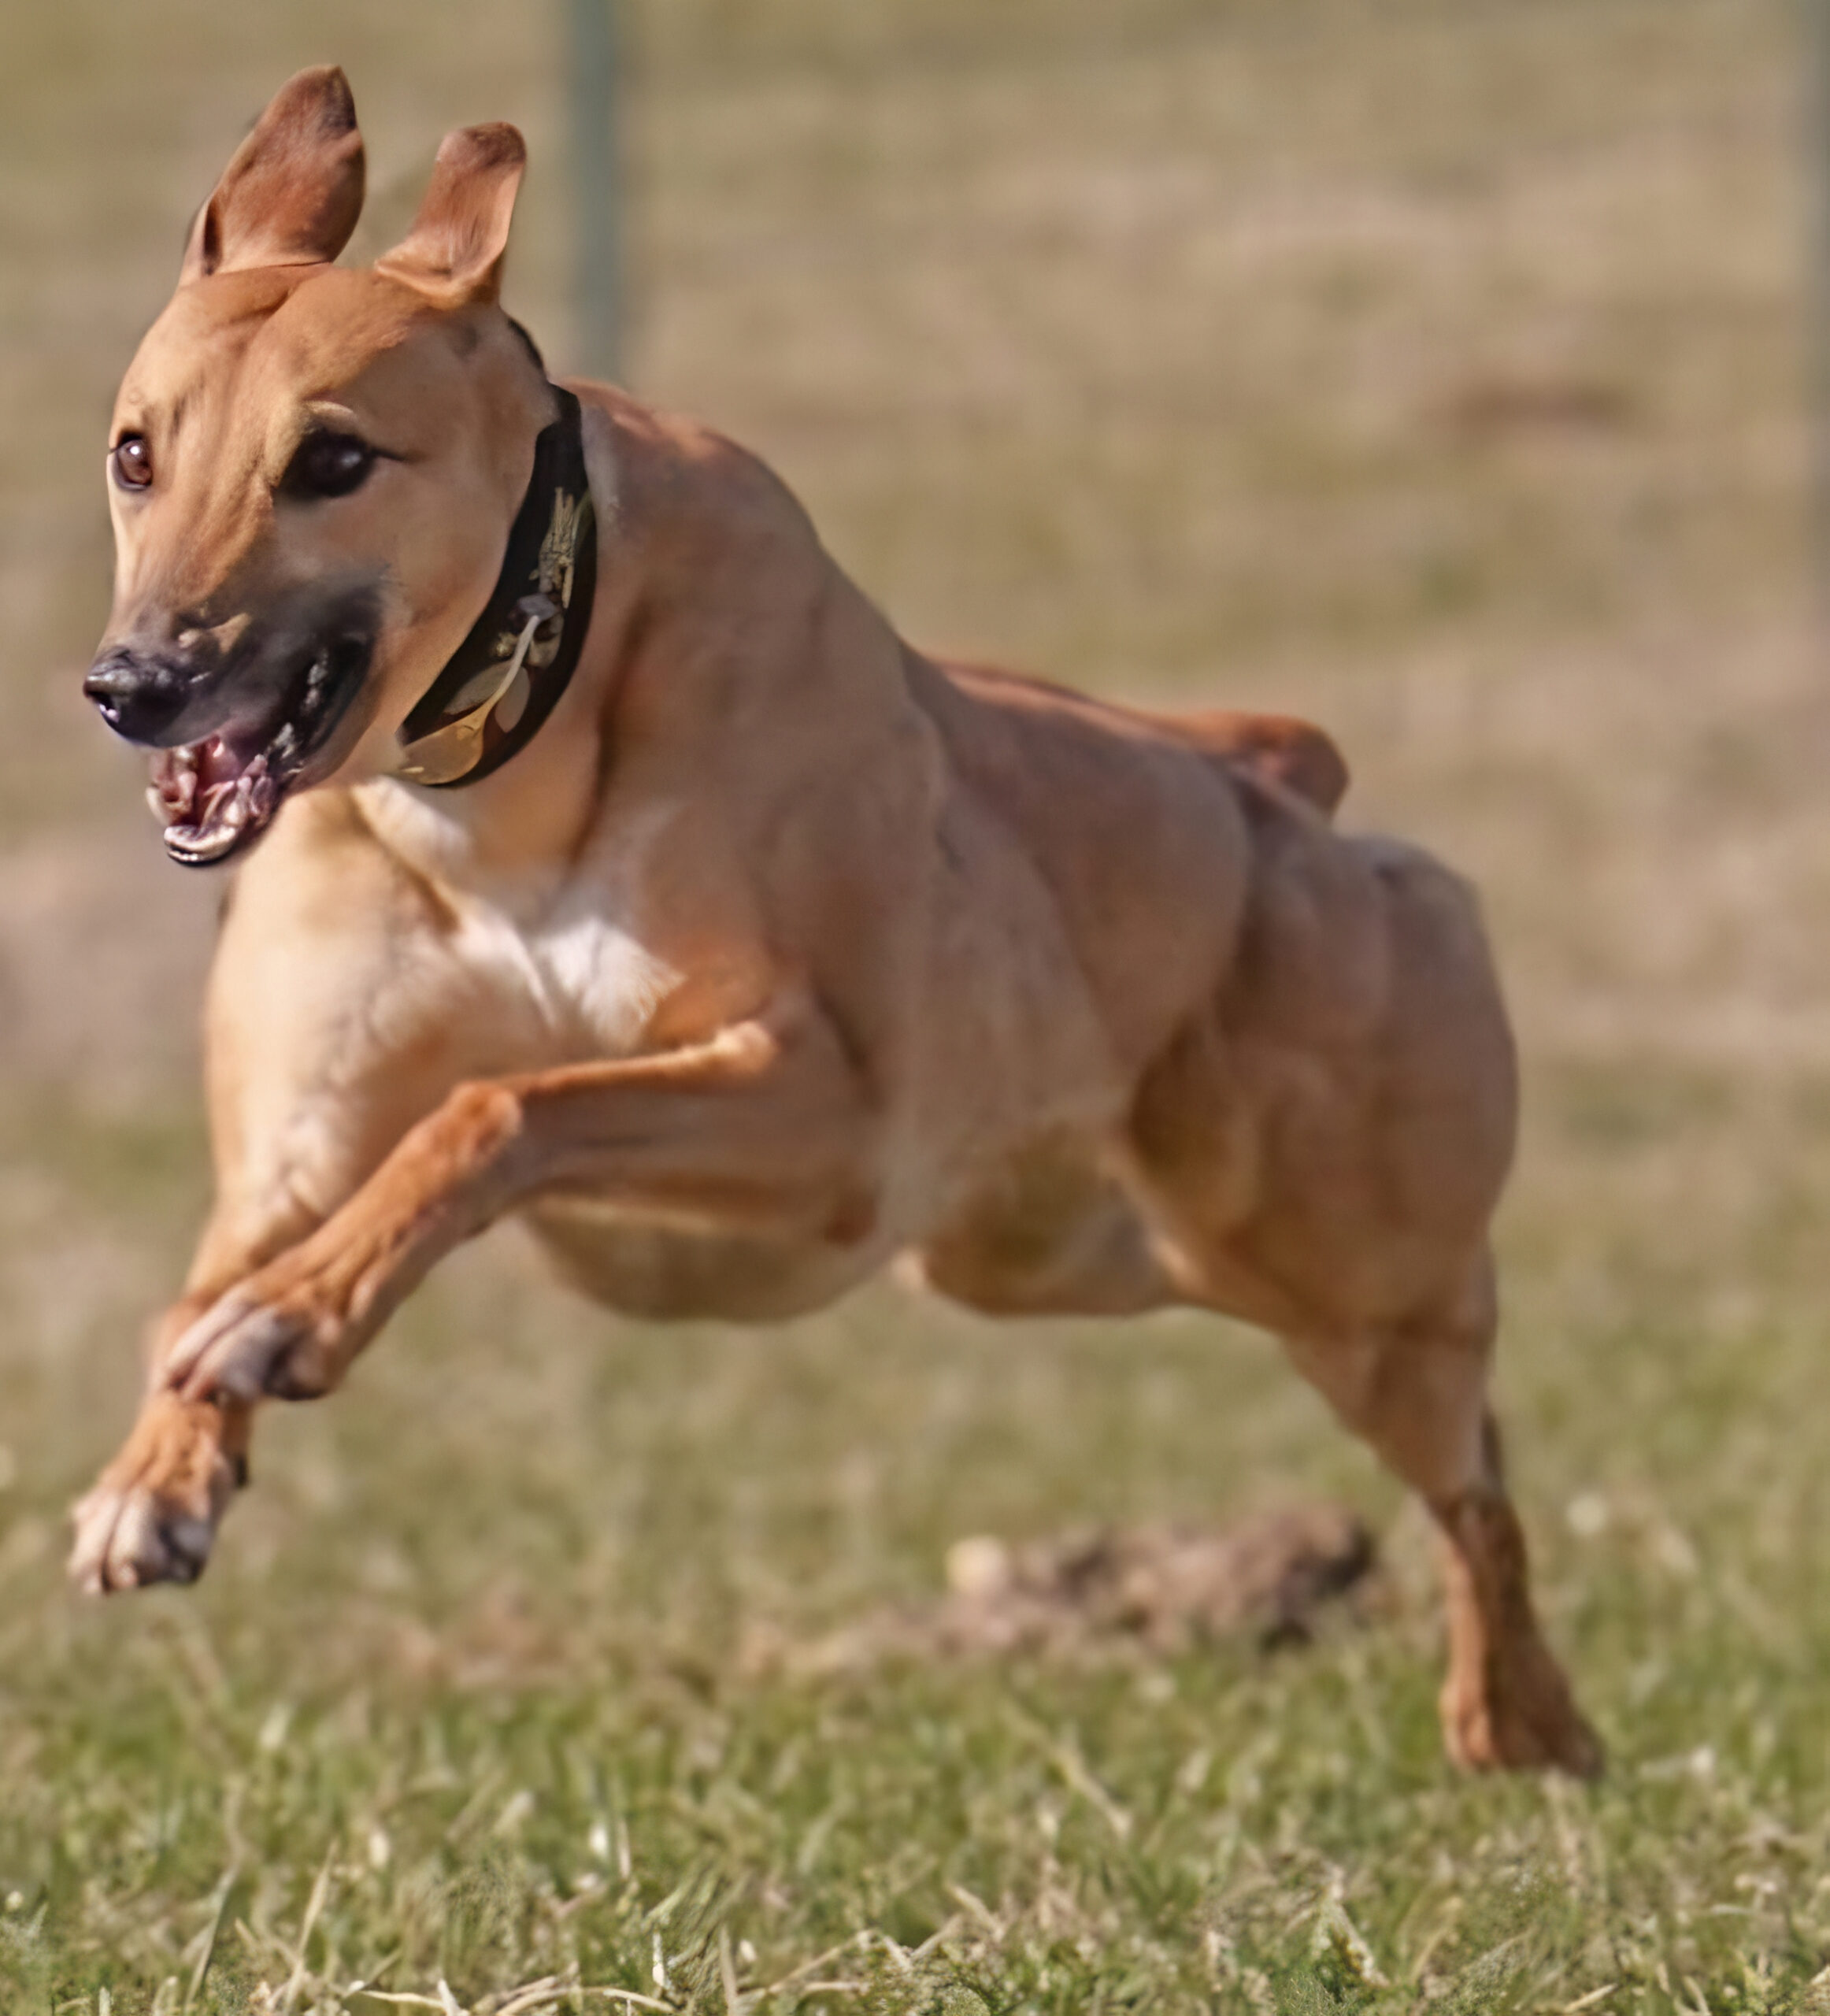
[520,1198,885,1322]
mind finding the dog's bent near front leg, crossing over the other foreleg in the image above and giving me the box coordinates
[161,1010,875,1407]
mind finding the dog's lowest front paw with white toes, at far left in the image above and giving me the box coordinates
[71,1393,246,1595]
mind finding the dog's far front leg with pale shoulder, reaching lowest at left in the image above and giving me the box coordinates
[71,795,564,1591]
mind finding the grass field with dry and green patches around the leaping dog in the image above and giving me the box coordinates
[0,0,1830,2016]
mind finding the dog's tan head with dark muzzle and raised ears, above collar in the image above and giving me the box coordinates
[84,69,552,865]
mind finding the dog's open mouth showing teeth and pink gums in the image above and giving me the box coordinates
[147,635,375,869]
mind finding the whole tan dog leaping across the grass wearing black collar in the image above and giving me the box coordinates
[72,69,1598,1774]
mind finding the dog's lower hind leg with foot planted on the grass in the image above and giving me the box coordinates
[1286,1260,1602,1778]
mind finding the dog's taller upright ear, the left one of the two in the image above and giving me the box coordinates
[180,66,363,282]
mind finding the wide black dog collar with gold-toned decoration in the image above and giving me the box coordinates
[395,385,597,791]
